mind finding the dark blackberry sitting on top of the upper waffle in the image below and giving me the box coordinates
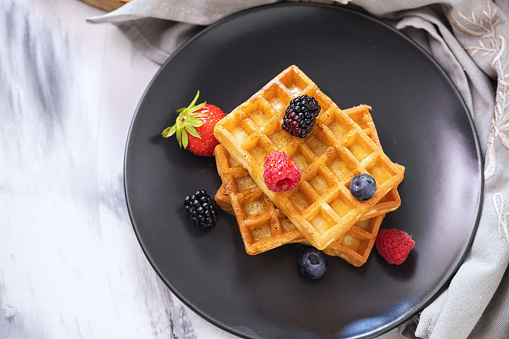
[282,95,320,138]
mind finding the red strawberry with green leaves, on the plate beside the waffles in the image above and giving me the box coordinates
[162,91,225,157]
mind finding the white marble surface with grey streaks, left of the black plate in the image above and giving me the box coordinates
[0,0,238,339]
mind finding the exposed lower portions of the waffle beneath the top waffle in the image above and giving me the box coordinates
[214,145,385,267]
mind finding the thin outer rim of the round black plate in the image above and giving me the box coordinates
[123,2,484,338]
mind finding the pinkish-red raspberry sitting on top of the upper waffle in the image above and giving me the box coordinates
[263,151,300,192]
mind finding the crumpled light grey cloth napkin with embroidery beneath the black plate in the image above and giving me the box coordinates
[89,0,509,338]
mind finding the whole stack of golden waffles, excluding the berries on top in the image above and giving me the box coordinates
[214,66,404,266]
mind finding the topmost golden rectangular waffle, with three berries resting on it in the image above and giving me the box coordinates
[214,66,403,250]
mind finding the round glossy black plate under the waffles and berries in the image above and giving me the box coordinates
[125,3,482,338]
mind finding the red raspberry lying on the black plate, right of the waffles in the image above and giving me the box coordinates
[375,228,415,265]
